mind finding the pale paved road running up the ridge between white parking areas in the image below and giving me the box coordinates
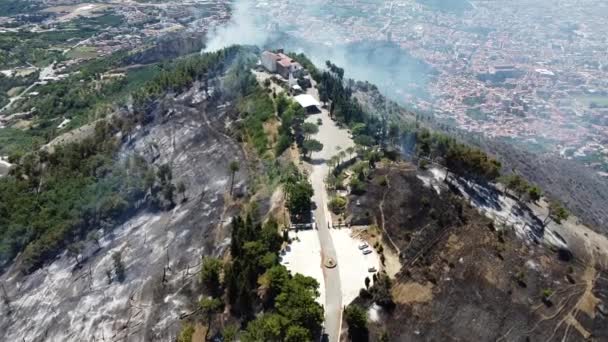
[306,81,354,342]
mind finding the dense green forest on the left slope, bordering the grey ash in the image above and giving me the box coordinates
[0,122,148,271]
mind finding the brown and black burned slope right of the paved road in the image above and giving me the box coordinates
[349,164,608,341]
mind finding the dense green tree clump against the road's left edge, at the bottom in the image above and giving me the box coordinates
[225,217,323,341]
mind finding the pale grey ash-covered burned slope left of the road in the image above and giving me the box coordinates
[0,75,248,341]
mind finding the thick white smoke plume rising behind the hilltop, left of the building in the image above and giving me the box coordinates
[204,0,269,52]
